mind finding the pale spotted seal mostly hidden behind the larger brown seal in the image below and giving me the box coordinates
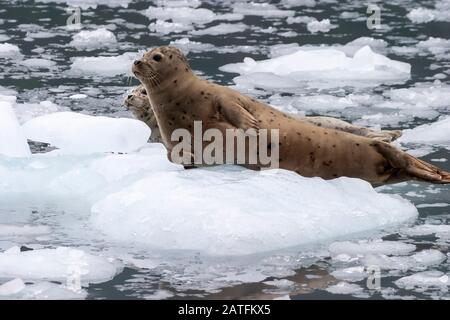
[124,84,402,142]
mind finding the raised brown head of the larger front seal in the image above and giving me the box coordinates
[132,46,191,88]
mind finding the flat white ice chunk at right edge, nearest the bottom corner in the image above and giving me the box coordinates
[395,271,450,289]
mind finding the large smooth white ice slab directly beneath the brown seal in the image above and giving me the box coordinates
[92,168,417,255]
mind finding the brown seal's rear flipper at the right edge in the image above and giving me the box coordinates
[373,142,450,184]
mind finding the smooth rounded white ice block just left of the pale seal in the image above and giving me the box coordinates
[23,112,150,154]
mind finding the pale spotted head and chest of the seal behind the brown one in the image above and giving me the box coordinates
[123,85,162,143]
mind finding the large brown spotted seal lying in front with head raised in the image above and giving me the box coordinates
[132,46,450,184]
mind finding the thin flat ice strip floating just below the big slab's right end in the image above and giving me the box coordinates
[329,240,416,257]
